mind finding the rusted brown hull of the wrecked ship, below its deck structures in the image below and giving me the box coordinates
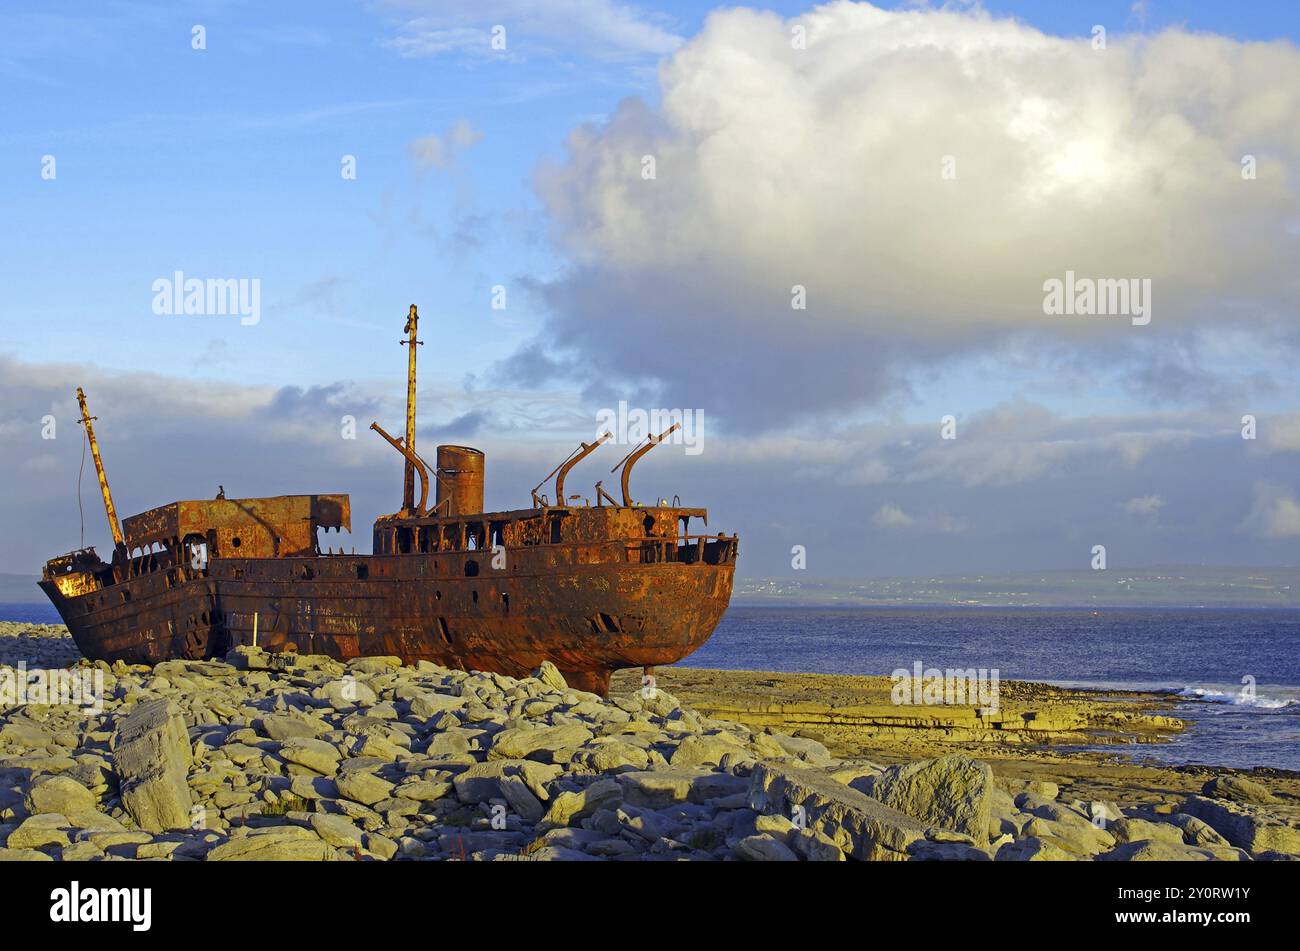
[42,550,735,695]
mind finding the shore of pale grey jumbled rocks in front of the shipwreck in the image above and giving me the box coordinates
[0,624,1300,861]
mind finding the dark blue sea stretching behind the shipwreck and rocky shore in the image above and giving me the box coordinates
[0,604,1300,770]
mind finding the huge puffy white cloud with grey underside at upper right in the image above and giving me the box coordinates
[527,1,1300,421]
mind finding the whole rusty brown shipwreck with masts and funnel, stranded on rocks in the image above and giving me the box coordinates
[40,305,737,695]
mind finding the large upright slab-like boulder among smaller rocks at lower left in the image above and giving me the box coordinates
[113,700,194,831]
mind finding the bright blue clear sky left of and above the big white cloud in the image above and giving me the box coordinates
[0,3,1300,386]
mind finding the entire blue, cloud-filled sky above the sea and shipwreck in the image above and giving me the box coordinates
[0,0,1300,578]
